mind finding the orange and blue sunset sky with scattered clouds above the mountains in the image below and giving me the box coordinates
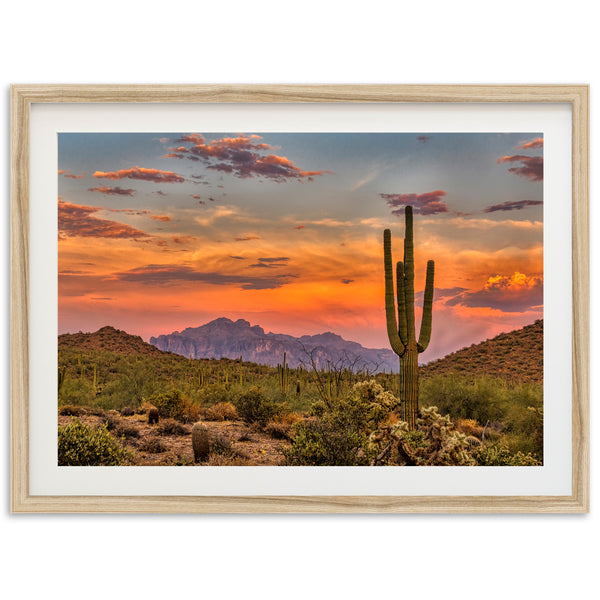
[58,132,543,362]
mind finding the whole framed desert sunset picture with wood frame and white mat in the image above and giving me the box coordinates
[11,85,589,513]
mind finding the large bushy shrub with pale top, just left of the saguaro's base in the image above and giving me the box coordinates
[285,380,398,466]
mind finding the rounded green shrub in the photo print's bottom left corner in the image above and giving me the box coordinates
[58,419,130,466]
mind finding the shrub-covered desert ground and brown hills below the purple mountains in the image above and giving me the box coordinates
[58,321,543,466]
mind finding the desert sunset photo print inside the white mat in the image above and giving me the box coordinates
[57,132,544,472]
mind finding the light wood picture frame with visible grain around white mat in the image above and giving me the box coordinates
[10,85,589,513]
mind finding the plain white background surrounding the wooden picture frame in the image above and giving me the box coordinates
[0,0,600,600]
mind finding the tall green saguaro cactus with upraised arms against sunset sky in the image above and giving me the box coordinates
[383,206,435,430]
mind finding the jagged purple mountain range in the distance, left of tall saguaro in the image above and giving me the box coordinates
[150,317,398,373]
